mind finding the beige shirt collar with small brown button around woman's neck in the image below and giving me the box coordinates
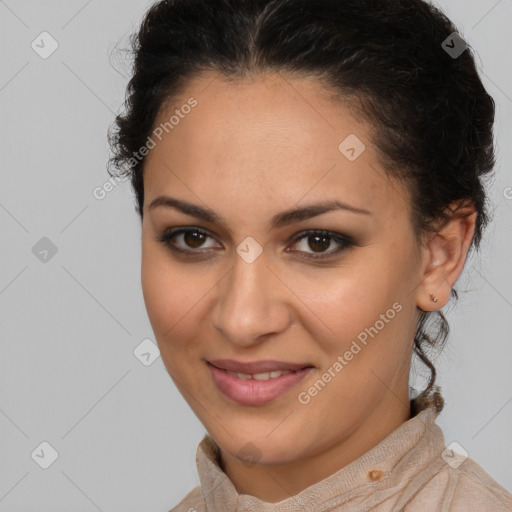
[196,400,444,512]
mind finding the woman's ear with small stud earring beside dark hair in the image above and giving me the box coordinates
[416,200,477,311]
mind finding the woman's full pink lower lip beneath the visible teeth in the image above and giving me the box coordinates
[208,363,312,405]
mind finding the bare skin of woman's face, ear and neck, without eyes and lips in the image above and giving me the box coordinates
[141,72,476,503]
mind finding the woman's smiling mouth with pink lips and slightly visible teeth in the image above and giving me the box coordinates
[207,359,314,405]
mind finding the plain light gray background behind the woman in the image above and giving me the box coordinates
[0,0,512,512]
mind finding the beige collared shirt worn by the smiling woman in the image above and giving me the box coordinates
[170,405,512,512]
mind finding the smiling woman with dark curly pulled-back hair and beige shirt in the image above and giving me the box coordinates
[107,0,512,512]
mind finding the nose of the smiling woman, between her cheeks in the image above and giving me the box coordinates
[212,251,292,347]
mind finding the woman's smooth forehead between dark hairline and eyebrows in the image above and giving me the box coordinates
[144,72,408,220]
